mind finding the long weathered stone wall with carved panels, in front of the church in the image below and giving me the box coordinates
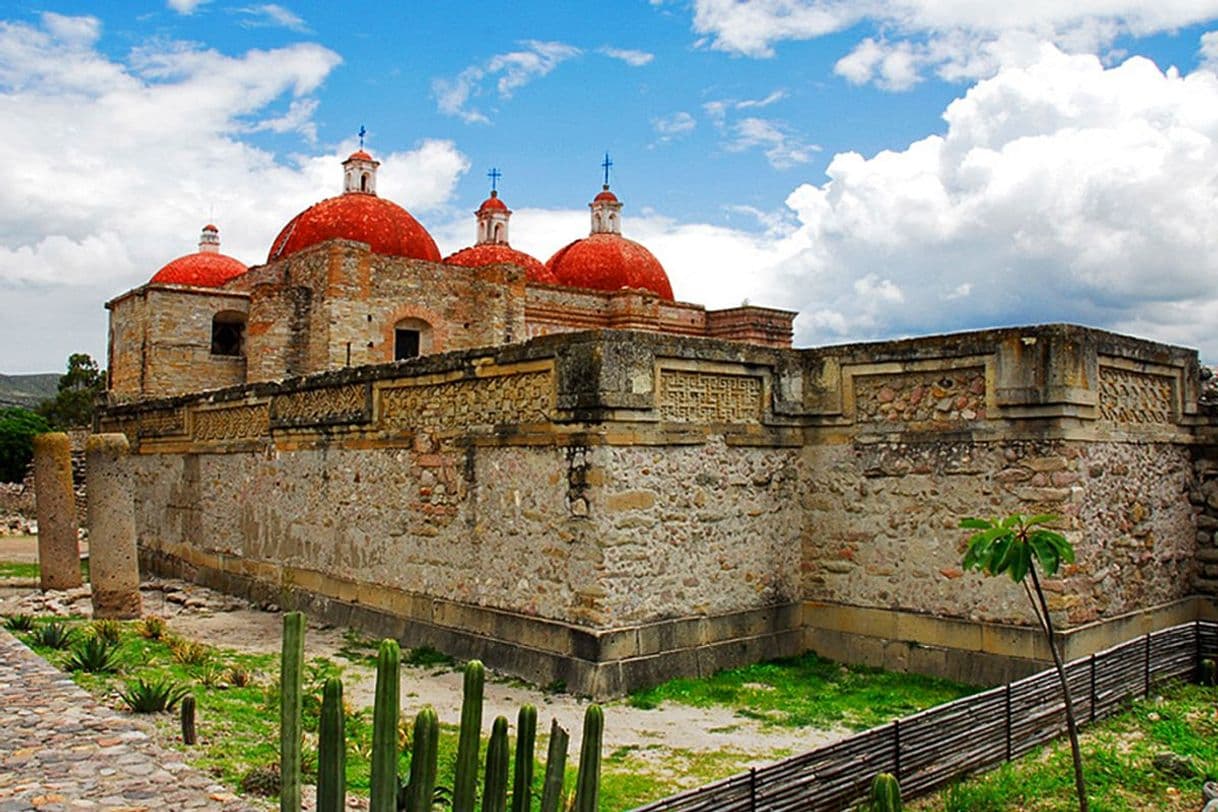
[102,325,1218,694]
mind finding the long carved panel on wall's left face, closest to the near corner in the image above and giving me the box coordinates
[380,371,554,431]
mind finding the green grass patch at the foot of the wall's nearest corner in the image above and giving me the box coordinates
[628,654,978,730]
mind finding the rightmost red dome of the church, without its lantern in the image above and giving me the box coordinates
[546,231,672,301]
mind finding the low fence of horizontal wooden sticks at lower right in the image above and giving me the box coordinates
[636,621,1218,812]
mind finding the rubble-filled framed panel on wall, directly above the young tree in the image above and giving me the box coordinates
[854,366,985,422]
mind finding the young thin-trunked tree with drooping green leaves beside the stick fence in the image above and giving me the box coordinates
[960,514,1088,812]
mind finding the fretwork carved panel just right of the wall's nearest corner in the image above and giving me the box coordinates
[659,369,764,424]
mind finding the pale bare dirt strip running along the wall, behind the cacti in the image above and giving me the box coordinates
[0,536,848,769]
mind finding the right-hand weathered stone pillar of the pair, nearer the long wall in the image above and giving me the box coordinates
[85,435,143,618]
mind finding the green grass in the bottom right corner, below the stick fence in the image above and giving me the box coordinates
[912,685,1218,812]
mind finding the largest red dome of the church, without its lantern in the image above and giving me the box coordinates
[267,193,440,262]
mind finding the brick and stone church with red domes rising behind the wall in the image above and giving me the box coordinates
[106,147,795,399]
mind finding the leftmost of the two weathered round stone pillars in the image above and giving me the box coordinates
[34,431,80,589]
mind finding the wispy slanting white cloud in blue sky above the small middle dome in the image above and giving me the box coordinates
[431,39,582,124]
